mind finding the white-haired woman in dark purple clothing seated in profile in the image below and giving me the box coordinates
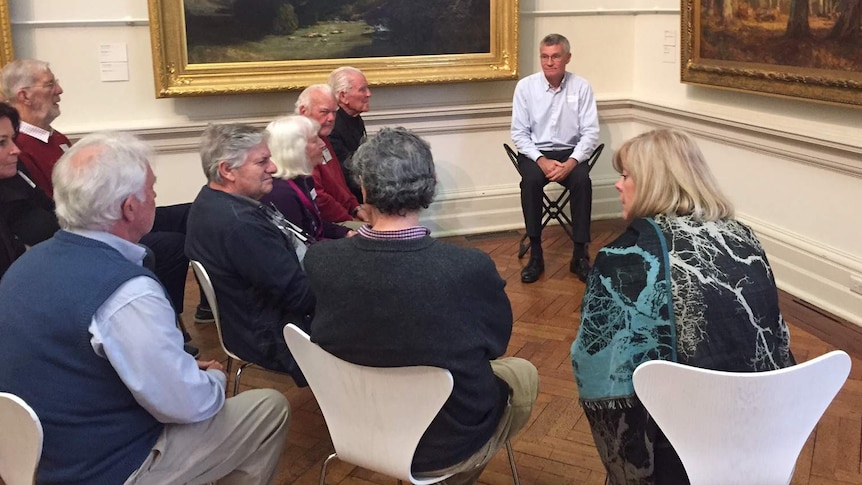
[261,115,353,244]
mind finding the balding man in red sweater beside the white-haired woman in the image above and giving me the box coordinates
[296,84,368,225]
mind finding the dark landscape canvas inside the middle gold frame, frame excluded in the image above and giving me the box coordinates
[184,0,491,64]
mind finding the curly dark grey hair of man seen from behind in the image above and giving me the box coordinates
[352,127,437,216]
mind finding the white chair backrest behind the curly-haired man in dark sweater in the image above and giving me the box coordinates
[284,324,460,484]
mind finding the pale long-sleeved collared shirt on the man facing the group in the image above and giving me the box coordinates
[512,72,599,162]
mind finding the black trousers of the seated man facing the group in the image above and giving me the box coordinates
[518,150,593,243]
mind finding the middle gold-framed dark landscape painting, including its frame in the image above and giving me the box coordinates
[149,0,518,97]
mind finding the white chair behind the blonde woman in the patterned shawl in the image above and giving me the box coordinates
[634,350,850,485]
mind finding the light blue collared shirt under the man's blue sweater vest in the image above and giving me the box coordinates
[77,230,226,423]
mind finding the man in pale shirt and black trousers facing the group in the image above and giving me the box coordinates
[512,34,599,283]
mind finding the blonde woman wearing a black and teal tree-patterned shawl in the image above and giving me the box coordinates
[572,130,795,485]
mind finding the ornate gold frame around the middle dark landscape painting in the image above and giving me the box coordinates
[148,0,518,98]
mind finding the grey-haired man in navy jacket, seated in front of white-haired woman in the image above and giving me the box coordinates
[186,124,315,386]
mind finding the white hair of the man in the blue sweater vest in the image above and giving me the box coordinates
[51,132,152,231]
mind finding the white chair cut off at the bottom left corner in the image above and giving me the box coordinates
[0,392,42,485]
